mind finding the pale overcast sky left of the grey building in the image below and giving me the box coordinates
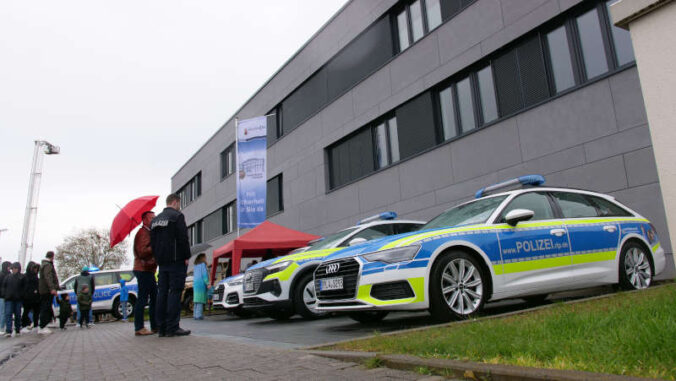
[0,0,347,261]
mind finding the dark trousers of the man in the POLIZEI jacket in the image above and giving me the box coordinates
[157,262,187,333]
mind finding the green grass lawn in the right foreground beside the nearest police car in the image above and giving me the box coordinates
[325,283,676,380]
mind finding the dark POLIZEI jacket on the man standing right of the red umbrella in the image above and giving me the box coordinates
[150,208,190,266]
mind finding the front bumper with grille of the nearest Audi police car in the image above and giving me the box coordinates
[315,258,428,311]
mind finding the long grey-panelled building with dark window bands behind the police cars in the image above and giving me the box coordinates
[172,0,673,276]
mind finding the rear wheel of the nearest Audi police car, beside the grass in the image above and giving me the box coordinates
[619,242,653,290]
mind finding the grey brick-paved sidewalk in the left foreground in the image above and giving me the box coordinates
[0,323,434,381]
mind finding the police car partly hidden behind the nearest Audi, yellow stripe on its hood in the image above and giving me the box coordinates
[244,212,424,319]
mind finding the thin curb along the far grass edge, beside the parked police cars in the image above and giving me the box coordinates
[304,280,674,351]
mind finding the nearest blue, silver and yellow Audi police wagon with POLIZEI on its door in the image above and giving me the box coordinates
[314,175,665,322]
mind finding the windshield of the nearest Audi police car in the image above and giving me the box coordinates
[419,195,507,230]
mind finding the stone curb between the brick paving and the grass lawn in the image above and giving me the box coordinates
[306,351,652,381]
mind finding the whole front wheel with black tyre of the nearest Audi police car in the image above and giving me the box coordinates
[429,251,486,321]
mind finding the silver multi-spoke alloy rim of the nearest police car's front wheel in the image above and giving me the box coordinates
[441,258,483,316]
